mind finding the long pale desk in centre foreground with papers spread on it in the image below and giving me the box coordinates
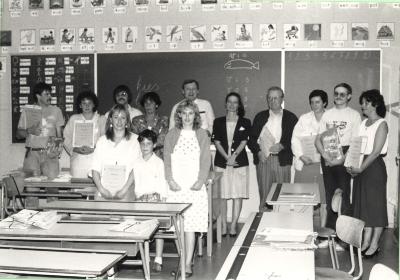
[216,212,315,280]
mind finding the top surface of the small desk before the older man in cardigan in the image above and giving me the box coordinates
[266,183,320,206]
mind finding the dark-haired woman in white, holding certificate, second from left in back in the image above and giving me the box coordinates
[64,91,106,178]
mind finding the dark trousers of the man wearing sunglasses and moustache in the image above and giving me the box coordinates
[321,147,351,229]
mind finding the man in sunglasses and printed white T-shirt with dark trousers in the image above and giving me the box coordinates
[315,83,361,228]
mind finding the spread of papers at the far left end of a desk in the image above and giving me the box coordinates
[0,209,60,229]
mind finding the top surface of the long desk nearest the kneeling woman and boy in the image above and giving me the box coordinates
[43,200,191,216]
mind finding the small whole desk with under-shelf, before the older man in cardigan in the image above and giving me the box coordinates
[266,183,320,215]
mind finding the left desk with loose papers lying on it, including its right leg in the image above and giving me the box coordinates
[0,223,158,279]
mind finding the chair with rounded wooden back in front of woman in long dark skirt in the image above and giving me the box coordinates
[315,215,366,280]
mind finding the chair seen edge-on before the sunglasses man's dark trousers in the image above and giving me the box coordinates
[317,189,343,269]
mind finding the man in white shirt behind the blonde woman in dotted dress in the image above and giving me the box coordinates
[169,79,215,135]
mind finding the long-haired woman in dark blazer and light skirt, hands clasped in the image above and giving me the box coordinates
[213,92,251,237]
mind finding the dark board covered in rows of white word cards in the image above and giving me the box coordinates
[11,54,94,143]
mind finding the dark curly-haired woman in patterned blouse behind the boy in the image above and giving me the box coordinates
[132,92,169,159]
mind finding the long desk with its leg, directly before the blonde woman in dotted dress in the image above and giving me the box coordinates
[43,200,190,279]
